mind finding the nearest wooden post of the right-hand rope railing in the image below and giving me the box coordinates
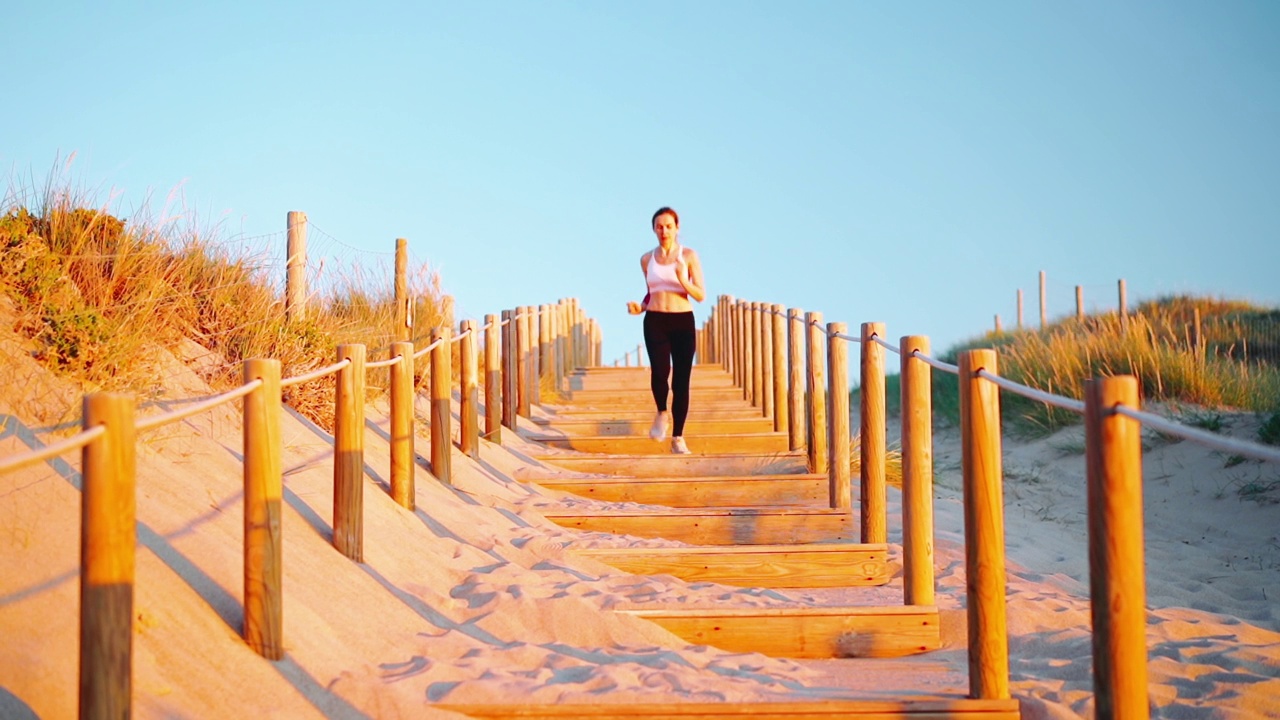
[1084,375,1148,720]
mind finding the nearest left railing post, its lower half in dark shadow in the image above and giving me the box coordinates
[79,392,137,720]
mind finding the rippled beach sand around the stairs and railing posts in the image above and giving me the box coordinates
[0,340,1280,719]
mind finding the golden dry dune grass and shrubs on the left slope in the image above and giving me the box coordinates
[0,187,447,427]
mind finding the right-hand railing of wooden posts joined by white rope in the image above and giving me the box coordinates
[699,289,1280,717]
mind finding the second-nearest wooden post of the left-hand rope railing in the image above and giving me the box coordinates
[241,359,284,660]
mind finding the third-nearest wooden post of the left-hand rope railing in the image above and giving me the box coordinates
[333,343,365,562]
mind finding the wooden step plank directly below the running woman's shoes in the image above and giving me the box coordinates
[535,448,808,478]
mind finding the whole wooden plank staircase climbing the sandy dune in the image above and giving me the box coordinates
[442,365,1020,720]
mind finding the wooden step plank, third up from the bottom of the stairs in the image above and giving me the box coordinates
[571,543,892,588]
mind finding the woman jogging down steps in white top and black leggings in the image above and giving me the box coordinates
[627,208,707,454]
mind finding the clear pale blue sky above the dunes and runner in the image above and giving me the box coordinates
[0,0,1280,360]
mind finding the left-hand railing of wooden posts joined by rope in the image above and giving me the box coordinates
[0,213,599,716]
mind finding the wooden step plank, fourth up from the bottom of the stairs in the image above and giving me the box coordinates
[543,507,858,544]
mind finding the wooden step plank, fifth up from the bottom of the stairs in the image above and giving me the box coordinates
[532,474,828,507]
